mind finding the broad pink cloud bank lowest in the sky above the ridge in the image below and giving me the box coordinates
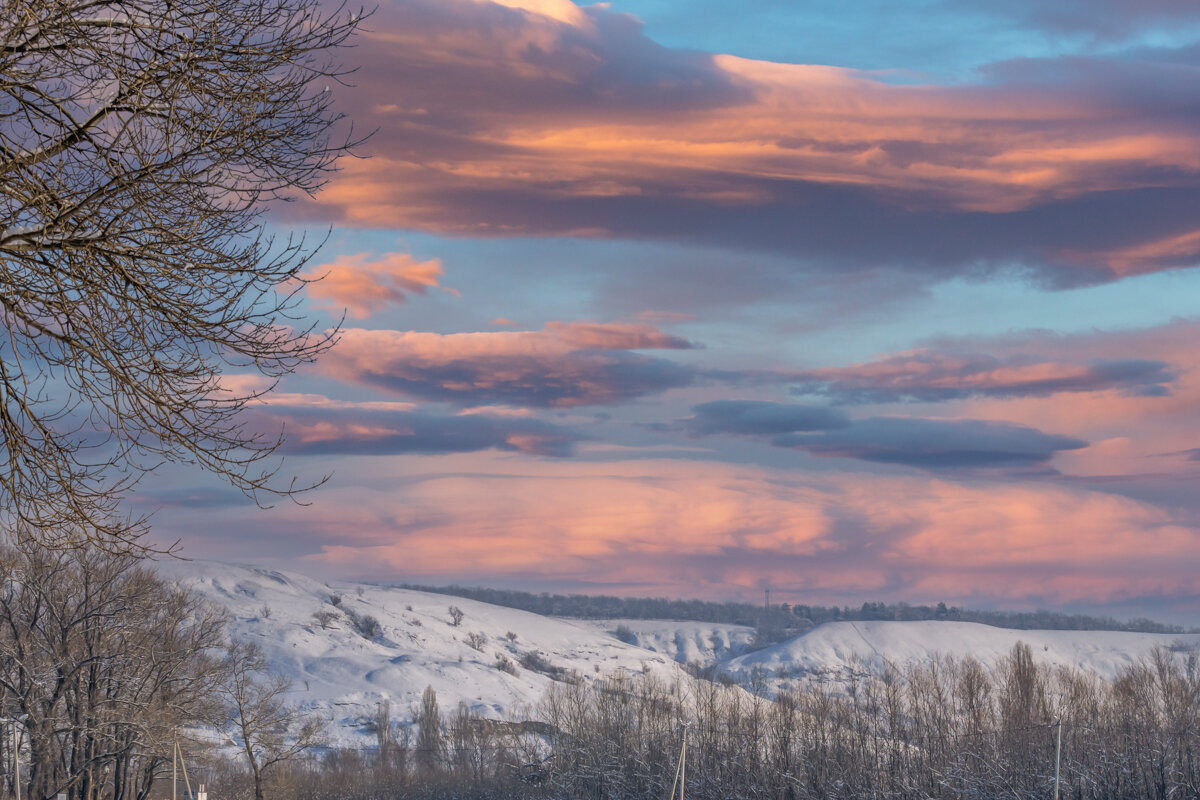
[248,456,1200,603]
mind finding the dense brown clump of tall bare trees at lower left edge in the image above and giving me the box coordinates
[0,547,226,800]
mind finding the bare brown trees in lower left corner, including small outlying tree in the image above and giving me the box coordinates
[0,545,322,800]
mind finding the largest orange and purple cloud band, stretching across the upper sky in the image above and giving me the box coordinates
[292,0,1200,281]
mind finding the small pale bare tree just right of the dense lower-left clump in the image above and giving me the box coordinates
[221,642,324,800]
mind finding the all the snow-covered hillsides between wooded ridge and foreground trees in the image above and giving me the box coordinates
[158,561,1200,745]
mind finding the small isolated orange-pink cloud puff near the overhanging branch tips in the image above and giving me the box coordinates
[302,253,442,319]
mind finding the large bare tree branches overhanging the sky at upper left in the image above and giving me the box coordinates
[0,0,361,552]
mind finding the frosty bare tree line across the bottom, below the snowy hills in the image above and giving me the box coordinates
[274,644,1200,800]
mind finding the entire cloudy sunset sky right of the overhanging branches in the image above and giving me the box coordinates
[134,0,1200,625]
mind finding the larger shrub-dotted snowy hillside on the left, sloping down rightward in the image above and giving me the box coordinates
[158,561,679,744]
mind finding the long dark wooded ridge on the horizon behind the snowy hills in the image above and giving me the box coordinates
[398,584,1187,633]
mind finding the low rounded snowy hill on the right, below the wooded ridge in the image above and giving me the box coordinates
[724,621,1200,680]
